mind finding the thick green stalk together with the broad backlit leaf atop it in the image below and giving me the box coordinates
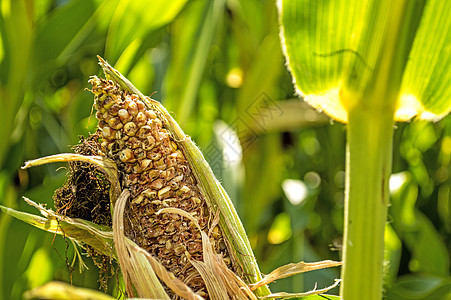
[278,0,451,300]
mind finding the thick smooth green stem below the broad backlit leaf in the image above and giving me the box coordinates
[340,106,394,300]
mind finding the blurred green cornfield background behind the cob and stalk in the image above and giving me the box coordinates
[0,0,451,299]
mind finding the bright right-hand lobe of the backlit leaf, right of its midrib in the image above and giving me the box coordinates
[397,0,451,120]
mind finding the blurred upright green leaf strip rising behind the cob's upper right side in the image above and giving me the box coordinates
[165,0,225,126]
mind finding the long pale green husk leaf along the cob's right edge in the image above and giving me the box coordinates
[98,57,269,296]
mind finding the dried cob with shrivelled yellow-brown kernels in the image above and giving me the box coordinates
[89,76,231,297]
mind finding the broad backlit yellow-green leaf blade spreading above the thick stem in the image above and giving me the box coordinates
[279,0,451,122]
